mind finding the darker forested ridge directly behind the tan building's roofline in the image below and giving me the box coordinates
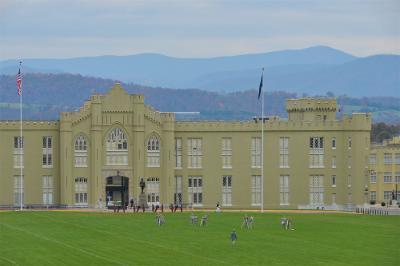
[0,74,400,124]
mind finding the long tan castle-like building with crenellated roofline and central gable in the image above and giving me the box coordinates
[0,83,371,209]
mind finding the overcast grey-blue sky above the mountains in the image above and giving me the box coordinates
[0,0,400,60]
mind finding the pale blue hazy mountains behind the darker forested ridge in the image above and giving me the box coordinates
[0,46,400,97]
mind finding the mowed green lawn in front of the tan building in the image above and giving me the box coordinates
[0,211,400,266]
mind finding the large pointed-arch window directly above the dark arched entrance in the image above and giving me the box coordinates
[106,128,128,165]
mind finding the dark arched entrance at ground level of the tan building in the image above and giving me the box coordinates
[106,173,129,208]
